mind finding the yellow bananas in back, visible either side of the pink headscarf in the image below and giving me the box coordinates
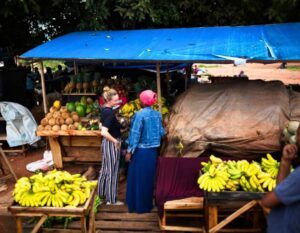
[120,97,169,118]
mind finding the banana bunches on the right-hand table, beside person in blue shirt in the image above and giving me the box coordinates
[198,154,288,192]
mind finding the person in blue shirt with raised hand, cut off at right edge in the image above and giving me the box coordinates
[261,127,300,233]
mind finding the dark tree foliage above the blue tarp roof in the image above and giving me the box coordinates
[0,0,300,54]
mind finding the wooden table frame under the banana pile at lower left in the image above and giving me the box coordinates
[8,188,96,233]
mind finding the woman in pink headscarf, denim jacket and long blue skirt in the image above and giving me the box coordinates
[125,90,165,213]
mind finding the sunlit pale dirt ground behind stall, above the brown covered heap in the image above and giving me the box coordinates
[205,63,300,85]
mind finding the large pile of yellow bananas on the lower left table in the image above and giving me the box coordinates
[13,170,97,207]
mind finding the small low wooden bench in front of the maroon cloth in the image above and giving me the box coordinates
[159,197,205,232]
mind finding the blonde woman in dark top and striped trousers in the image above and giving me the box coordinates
[98,87,124,205]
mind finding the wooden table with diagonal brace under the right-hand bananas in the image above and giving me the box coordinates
[204,191,267,233]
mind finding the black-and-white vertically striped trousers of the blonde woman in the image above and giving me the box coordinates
[98,138,120,203]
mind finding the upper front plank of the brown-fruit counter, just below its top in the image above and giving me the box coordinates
[59,136,102,147]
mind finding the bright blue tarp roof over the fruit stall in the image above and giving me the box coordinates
[21,23,300,63]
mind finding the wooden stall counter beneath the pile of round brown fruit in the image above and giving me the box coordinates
[36,130,101,168]
